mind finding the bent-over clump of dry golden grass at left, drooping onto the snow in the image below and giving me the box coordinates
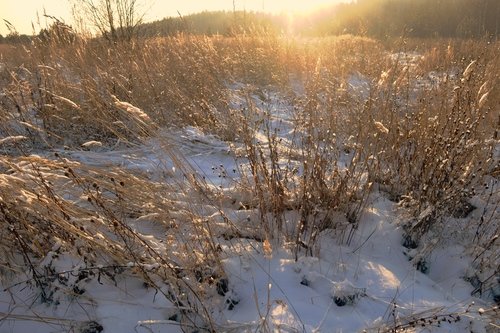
[0,151,227,326]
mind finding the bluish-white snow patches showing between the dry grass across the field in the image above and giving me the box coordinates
[0,61,496,333]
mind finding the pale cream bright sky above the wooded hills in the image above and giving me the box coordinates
[0,0,348,36]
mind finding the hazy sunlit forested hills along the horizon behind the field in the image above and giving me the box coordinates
[0,0,500,43]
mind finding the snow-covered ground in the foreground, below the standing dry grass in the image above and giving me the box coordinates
[0,157,498,333]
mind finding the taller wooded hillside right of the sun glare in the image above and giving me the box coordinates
[326,0,500,38]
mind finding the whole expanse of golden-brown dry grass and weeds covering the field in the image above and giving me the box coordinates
[0,34,500,327]
